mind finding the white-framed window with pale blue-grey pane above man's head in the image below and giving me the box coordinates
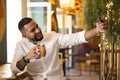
[27,2,51,32]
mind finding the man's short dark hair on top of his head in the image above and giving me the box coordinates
[18,17,32,31]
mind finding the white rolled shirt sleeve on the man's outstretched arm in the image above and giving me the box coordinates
[58,31,87,46]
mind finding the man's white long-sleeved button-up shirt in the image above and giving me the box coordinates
[11,31,86,80]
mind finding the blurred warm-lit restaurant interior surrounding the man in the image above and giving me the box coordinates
[0,0,120,80]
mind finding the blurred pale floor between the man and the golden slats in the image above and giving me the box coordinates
[66,69,99,80]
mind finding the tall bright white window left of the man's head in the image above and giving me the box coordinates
[6,0,22,62]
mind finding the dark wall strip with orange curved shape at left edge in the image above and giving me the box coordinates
[0,0,7,64]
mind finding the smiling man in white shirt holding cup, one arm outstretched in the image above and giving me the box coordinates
[11,17,107,80]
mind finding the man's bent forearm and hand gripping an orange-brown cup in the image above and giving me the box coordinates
[16,46,46,71]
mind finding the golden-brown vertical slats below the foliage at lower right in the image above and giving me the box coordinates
[100,49,120,80]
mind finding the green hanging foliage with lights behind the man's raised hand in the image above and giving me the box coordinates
[84,0,120,41]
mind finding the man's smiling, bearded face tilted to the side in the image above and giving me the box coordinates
[23,20,43,41]
